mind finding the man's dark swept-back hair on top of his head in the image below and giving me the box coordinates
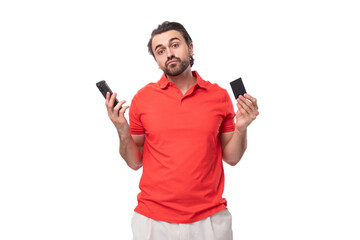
[148,21,194,66]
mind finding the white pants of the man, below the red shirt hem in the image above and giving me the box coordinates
[131,209,233,240]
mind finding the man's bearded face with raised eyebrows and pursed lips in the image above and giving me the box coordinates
[152,30,193,76]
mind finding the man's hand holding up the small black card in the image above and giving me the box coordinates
[235,93,259,132]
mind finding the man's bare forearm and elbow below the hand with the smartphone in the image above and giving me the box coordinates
[119,134,142,170]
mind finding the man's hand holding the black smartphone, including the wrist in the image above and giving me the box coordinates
[105,92,130,138]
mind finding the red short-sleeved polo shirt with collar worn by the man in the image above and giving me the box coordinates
[129,71,235,223]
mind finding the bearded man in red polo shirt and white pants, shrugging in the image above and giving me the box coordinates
[106,22,259,240]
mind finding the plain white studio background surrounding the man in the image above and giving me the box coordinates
[0,0,360,240]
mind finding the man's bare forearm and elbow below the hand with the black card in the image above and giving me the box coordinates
[222,129,247,166]
